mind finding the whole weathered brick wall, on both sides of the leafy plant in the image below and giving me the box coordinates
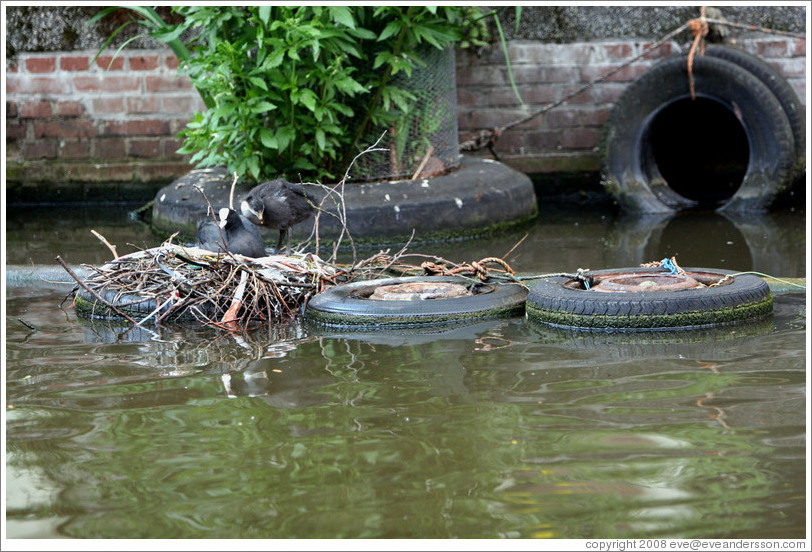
[6,38,806,190]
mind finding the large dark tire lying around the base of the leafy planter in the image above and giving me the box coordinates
[152,156,538,245]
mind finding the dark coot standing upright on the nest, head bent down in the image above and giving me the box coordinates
[240,178,313,253]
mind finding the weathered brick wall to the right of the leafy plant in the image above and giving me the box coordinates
[457,38,806,174]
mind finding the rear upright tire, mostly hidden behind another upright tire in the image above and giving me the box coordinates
[686,44,806,177]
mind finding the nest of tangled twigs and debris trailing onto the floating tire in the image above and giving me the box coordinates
[65,238,513,330]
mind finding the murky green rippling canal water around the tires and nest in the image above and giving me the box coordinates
[4,199,807,539]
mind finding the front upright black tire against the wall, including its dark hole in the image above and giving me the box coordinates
[601,54,797,213]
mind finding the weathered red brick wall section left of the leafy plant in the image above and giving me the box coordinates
[6,50,204,182]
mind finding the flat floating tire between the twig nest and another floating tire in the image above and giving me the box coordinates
[305,276,527,328]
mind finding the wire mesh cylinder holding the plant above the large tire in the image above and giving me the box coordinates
[352,46,460,182]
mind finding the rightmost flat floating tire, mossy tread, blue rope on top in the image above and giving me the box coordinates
[526,268,773,330]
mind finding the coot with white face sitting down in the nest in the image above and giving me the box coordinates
[197,207,266,258]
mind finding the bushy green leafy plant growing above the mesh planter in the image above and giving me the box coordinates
[97,6,482,181]
